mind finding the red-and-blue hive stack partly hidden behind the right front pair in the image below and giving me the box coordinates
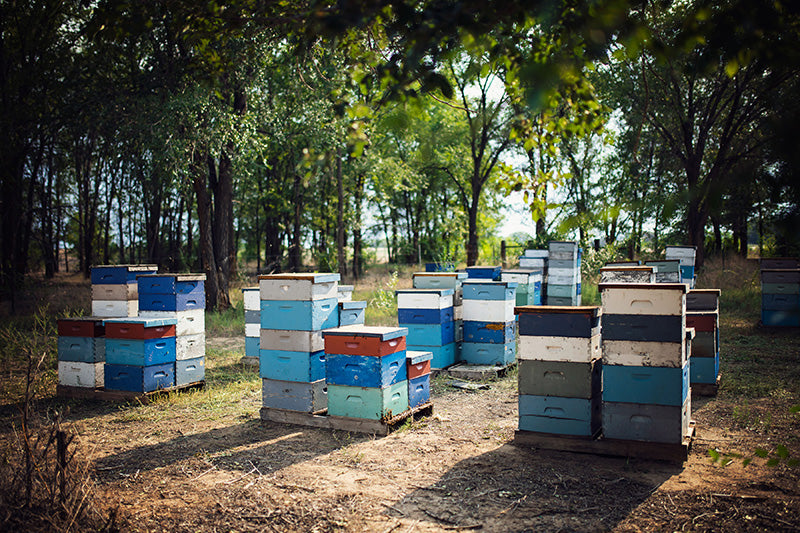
[686,289,720,385]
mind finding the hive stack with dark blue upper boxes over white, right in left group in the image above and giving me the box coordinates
[137,274,206,387]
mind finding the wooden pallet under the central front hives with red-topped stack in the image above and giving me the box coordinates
[261,402,433,435]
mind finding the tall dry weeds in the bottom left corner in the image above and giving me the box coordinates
[0,307,117,531]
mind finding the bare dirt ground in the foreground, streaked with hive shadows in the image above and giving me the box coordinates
[28,339,800,532]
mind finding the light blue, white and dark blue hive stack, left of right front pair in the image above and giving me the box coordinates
[461,279,517,366]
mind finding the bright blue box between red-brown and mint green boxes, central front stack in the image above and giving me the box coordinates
[325,350,407,388]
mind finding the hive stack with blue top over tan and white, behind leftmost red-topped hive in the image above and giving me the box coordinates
[91,265,158,318]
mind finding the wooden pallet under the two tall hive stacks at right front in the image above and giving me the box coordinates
[514,421,694,463]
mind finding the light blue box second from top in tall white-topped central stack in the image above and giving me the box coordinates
[261,298,339,331]
